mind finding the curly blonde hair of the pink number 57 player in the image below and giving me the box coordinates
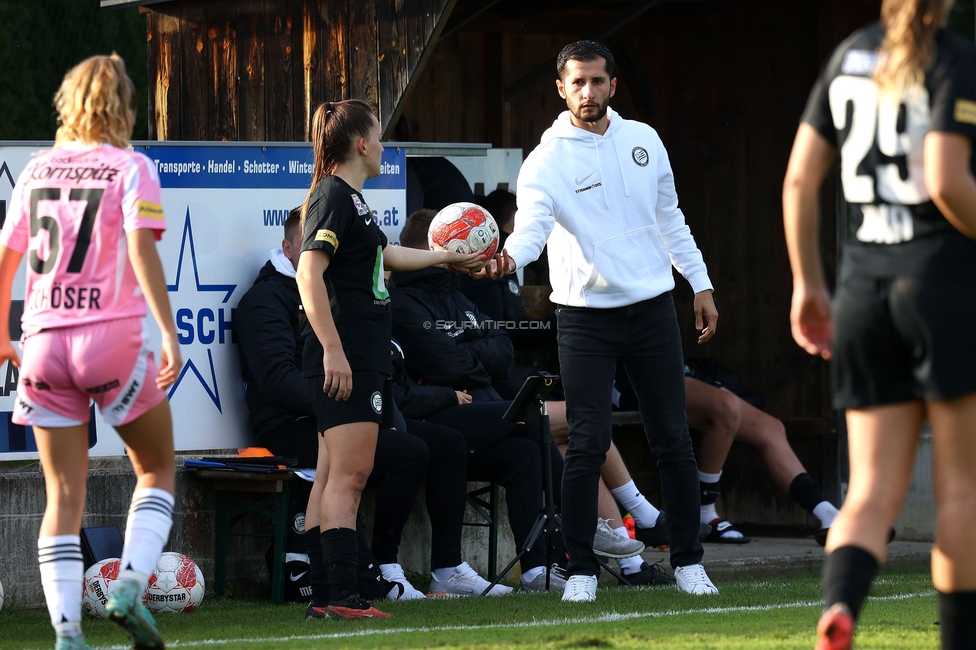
[54,52,136,148]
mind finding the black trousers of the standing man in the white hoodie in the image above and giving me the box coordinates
[556,293,702,576]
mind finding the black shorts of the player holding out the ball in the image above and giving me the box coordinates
[305,370,393,433]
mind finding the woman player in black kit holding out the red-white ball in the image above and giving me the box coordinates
[296,99,480,619]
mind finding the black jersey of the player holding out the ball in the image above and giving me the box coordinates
[302,176,393,377]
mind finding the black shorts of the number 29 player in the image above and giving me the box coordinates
[831,278,976,409]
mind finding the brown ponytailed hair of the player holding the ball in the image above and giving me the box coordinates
[302,99,376,228]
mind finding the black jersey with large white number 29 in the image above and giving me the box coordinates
[802,23,976,278]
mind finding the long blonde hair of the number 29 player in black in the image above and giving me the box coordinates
[874,0,955,96]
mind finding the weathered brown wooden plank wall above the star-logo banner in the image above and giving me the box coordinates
[147,0,454,141]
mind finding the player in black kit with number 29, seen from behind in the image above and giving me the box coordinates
[783,0,976,650]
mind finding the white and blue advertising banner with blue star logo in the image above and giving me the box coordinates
[0,143,407,460]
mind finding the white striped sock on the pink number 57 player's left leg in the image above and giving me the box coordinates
[37,535,85,636]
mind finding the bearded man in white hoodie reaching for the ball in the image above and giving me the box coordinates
[486,41,718,602]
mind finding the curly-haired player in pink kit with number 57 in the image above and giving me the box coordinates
[0,54,182,650]
